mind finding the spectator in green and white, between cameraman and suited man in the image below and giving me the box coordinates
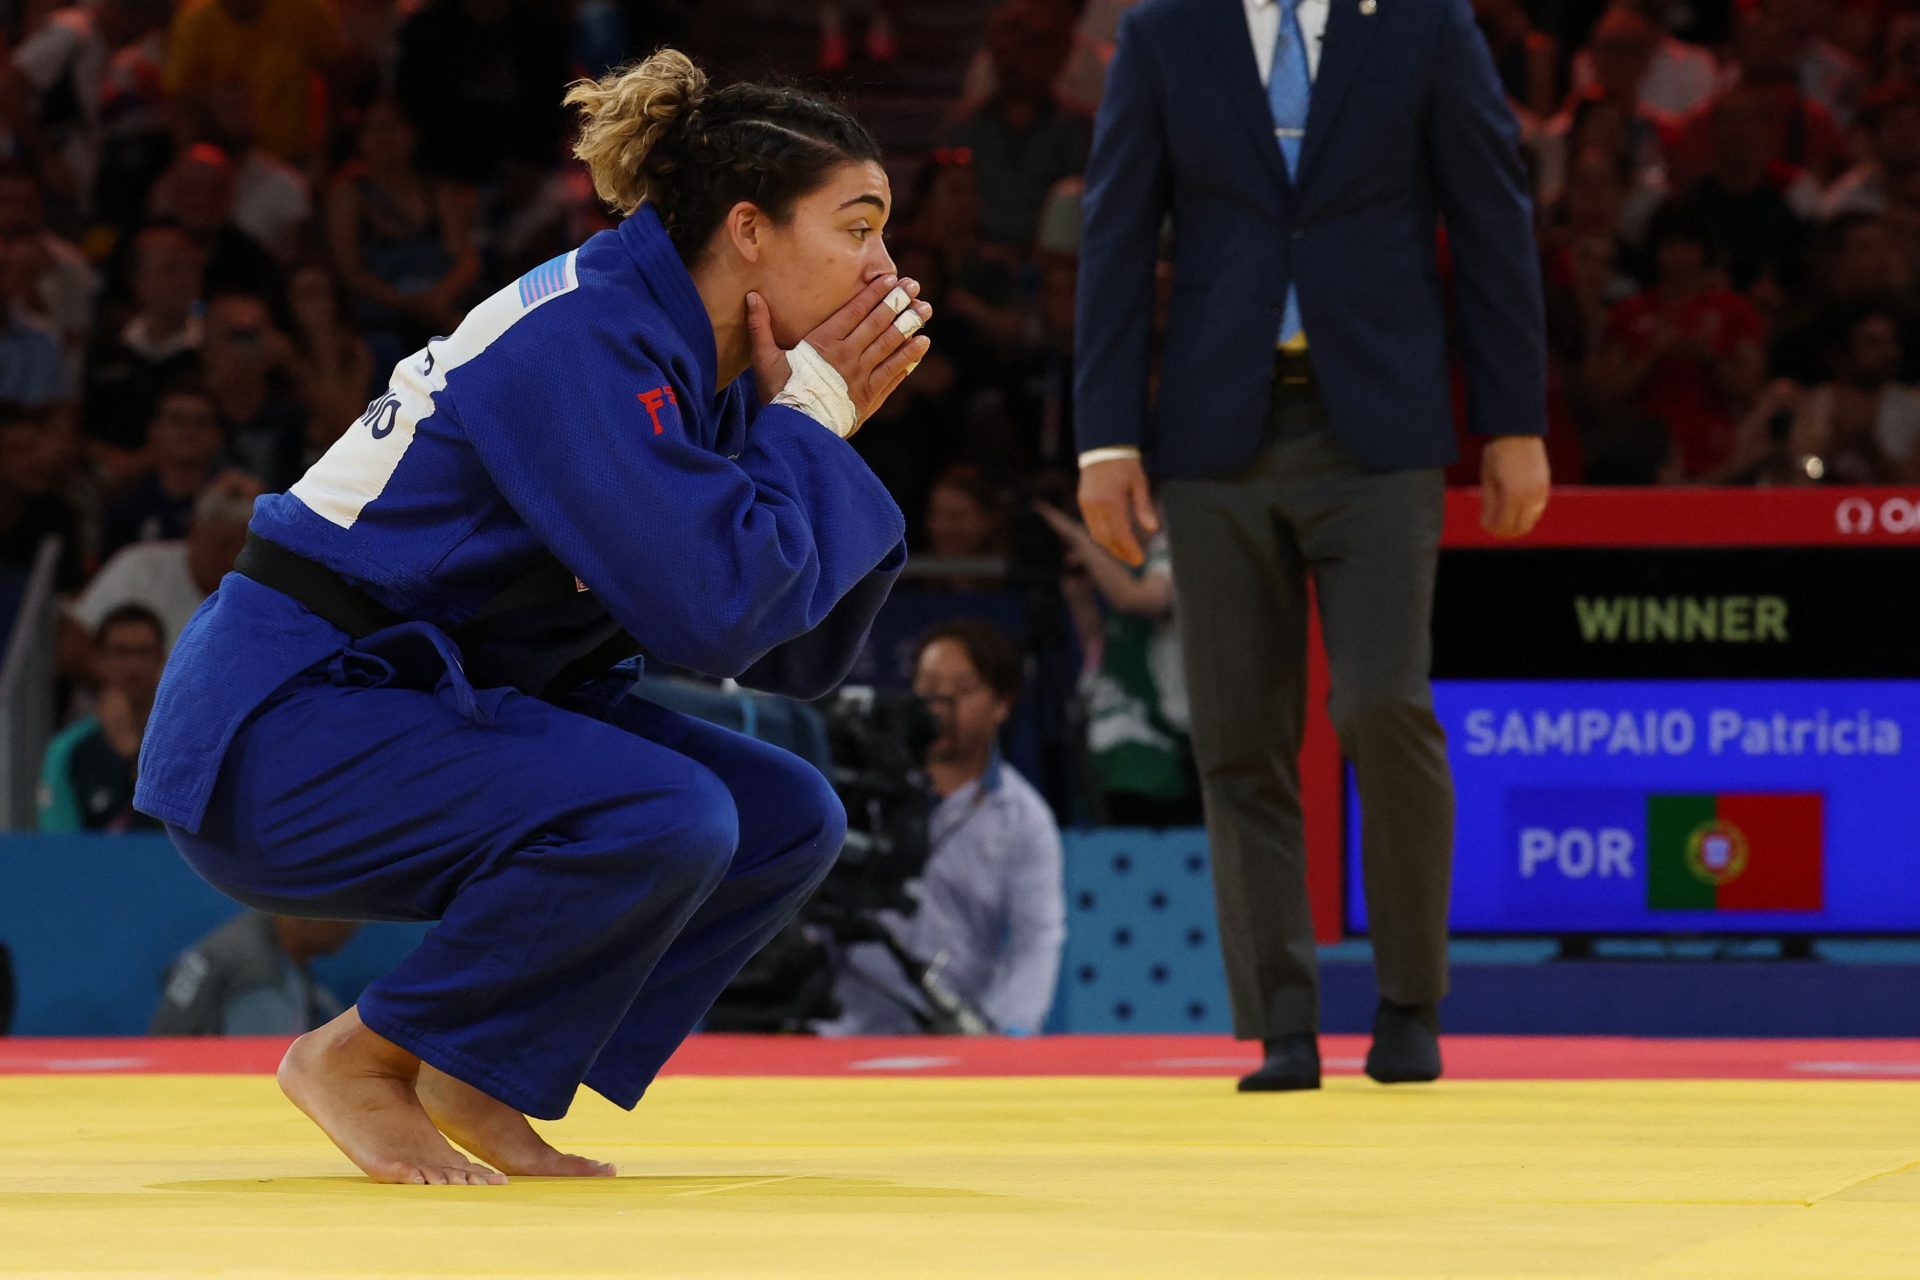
[1035,503,1200,827]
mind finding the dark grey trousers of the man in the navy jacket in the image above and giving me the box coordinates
[1162,395,1453,1040]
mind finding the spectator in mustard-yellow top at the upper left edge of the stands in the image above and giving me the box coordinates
[167,0,342,165]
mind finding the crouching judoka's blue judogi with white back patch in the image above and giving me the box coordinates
[134,207,906,1119]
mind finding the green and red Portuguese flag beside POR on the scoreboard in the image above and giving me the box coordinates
[1647,791,1824,912]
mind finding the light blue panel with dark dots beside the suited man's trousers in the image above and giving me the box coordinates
[1048,827,1233,1032]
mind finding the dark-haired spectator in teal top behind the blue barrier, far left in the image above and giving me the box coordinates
[40,604,167,835]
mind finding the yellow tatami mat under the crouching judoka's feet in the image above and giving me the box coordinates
[0,1075,1920,1280]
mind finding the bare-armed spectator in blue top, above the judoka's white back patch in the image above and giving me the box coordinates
[326,100,480,368]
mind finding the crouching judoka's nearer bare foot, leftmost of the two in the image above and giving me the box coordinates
[278,1009,507,1186]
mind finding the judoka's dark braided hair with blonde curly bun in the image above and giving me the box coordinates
[566,48,879,263]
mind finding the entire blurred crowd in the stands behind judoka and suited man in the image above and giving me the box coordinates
[11,0,1920,844]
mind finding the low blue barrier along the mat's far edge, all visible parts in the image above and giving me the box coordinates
[11,831,1920,1036]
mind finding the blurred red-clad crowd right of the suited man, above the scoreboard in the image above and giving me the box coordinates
[1505,0,1920,484]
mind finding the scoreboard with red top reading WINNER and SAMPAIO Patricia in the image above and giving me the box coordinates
[1342,489,1920,935]
